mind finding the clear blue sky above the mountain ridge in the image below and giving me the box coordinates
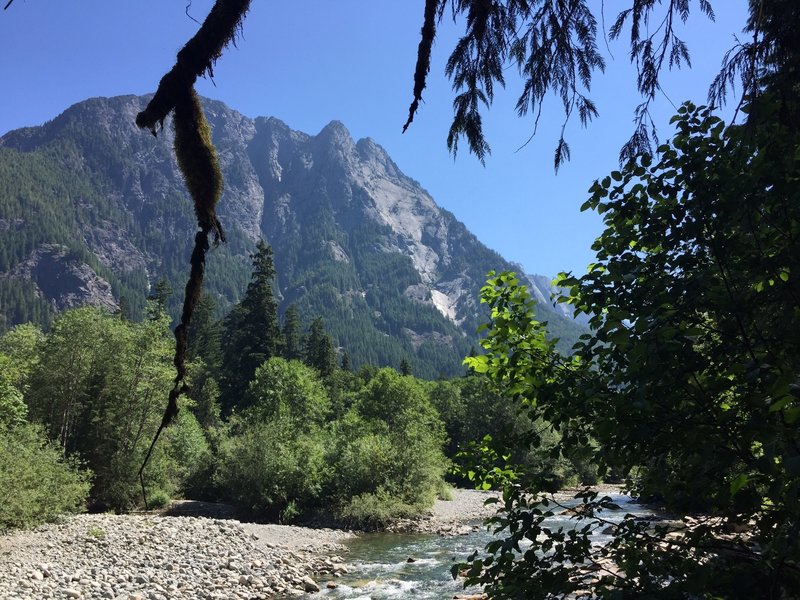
[0,0,747,275]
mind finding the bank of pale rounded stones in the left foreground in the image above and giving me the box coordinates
[0,514,347,600]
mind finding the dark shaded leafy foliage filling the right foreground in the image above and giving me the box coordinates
[460,97,800,598]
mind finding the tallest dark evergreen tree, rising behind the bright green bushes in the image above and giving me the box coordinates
[221,240,283,411]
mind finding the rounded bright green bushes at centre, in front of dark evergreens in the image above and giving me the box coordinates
[214,358,447,527]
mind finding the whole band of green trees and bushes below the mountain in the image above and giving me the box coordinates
[0,243,584,528]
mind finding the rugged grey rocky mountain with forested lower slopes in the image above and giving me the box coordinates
[0,96,583,377]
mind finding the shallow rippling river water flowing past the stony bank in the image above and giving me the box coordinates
[300,494,652,600]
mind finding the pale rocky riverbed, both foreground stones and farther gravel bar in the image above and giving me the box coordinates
[0,490,612,600]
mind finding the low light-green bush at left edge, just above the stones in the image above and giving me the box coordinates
[0,424,91,528]
